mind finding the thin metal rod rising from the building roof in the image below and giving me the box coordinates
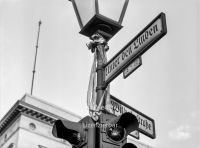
[31,20,42,95]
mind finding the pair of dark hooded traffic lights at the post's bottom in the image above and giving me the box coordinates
[52,112,138,148]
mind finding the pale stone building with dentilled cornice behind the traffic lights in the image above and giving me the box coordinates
[0,94,151,148]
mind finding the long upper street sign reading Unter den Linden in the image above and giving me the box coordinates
[104,13,167,85]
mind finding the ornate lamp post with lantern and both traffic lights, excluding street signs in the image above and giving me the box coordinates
[52,0,141,148]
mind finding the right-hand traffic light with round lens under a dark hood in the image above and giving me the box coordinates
[100,112,139,148]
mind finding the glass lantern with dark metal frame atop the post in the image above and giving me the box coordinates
[70,0,129,40]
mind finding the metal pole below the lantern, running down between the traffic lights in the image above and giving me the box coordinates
[88,34,108,148]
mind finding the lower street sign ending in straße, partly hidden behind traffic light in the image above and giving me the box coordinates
[110,95,156,139]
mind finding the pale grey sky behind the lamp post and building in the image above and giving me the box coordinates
[0,0,200,148]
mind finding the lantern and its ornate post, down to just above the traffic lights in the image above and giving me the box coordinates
[69,0,129,117]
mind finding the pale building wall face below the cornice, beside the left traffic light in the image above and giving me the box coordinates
[15,115,71,148]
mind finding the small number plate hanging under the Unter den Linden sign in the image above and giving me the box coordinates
[123,57,142,79]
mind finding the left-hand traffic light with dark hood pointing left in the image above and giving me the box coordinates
[52,116,95,148]
